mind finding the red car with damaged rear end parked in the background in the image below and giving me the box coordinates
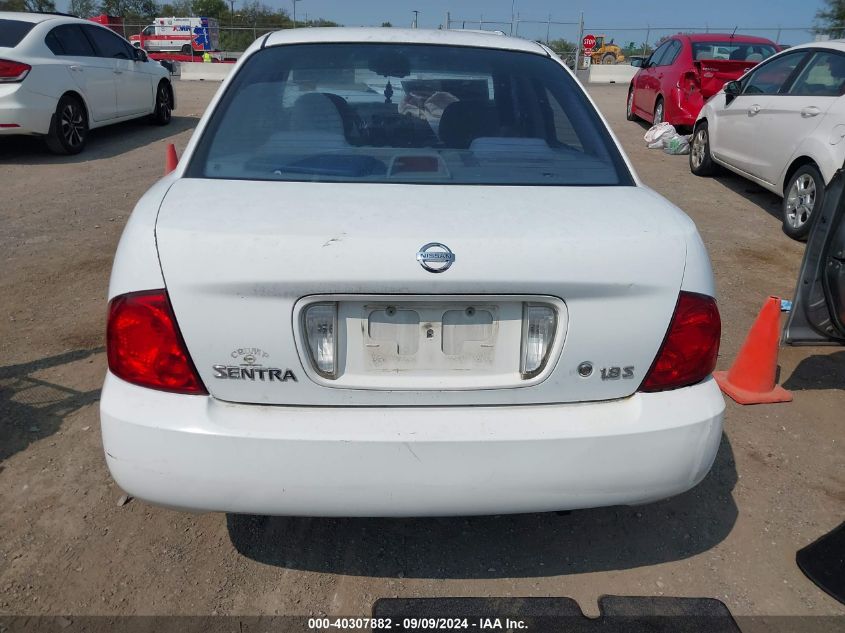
[626,33,780,127]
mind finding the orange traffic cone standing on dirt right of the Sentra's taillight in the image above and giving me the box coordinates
[713,297,792,404]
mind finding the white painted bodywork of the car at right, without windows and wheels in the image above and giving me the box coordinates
[698,41,845,197]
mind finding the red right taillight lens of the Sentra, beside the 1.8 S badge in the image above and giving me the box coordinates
[640,291,722,391]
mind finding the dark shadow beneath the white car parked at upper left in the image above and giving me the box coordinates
[0,115,199,165]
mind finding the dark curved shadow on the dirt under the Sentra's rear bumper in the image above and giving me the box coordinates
[227,435,737,579]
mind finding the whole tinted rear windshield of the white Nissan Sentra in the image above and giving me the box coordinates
[187,44,632,185]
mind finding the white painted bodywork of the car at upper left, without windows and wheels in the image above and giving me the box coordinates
[0,12,170,135]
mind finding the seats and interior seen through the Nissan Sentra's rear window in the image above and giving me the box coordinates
[193,47,619,184]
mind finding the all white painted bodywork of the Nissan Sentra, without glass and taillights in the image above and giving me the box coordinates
[101,29,725,516]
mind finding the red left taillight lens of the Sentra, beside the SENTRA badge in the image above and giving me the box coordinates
[106,290,208,395]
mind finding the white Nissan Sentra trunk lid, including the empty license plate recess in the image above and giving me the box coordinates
[156,179,689,406]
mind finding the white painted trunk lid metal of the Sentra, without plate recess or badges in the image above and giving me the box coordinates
[156,179,700,406]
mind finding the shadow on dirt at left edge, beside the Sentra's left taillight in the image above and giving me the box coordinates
[0,348,103,461]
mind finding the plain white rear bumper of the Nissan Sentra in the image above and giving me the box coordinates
[101,374,725,516]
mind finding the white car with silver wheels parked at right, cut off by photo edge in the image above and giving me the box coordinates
[689,41,845,239]
